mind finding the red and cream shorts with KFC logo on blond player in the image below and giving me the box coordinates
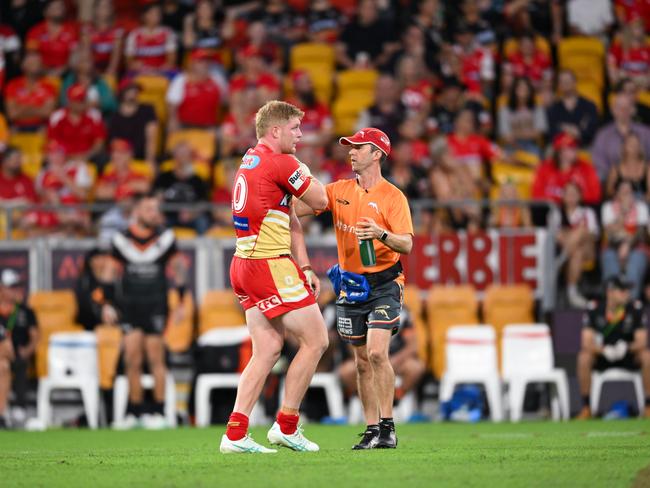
[230,256,316,319]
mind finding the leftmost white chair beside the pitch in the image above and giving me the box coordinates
[37,332,99,429]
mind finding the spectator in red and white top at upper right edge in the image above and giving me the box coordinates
[607,19,650,90]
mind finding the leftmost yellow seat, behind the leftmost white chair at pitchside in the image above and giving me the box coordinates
[29,290,83,378]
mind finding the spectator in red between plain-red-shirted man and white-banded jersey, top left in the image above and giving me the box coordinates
[82,0,126,77]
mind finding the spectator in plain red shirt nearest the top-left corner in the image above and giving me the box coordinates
[26,0,79,76]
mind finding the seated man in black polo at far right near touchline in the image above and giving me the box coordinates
[578,275,650,419]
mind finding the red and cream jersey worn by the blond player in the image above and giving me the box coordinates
[232,143,311,259]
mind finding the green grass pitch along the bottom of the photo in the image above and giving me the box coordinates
[0,420,650,488]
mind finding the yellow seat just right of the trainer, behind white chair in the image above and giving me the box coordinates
[427,285,478,378]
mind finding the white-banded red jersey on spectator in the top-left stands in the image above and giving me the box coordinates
[125,27,176,68]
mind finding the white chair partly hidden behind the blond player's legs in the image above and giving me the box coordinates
[194,326,267,427]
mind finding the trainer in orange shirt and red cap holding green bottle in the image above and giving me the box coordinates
[295,128,413,450]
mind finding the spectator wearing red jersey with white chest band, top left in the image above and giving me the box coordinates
[125,3,177,75]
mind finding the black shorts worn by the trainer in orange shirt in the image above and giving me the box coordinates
[336,281,404,346]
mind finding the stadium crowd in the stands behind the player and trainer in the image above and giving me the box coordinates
[0,0,650,307]
